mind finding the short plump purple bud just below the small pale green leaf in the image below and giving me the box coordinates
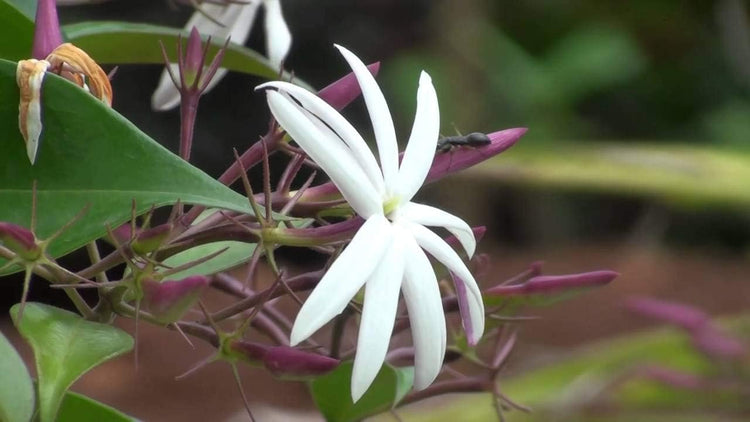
[141,275,211,324]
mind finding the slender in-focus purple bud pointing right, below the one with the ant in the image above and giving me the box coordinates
[484,270,620,296]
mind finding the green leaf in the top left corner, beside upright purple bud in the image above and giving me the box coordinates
[0,0,36,61]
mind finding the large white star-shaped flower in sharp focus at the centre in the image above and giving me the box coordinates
[258,46,484,401]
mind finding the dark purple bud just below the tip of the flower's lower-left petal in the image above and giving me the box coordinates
[263,346,341,380]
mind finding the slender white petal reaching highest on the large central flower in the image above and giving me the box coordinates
[336,45,398,192]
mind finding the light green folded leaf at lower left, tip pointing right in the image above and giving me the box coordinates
[10,303,133,422]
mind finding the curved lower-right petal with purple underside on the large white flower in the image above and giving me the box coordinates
[399,221,484,343]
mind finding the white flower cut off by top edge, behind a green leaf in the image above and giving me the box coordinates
[151,0,292,111]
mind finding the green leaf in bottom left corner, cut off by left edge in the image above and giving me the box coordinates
[0,333,34,422]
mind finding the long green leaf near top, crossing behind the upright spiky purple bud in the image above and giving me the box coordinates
[63,22,290,79]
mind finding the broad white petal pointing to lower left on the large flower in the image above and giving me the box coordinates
[290,215,393,346]
